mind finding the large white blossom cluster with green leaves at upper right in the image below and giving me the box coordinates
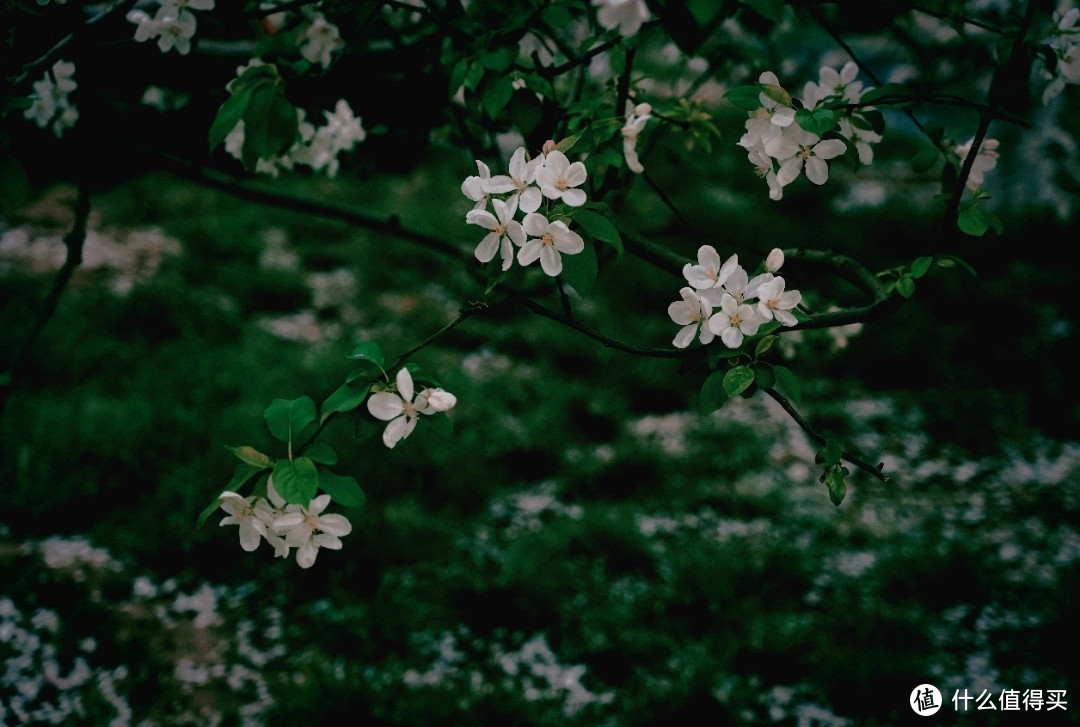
[739,63,881,200]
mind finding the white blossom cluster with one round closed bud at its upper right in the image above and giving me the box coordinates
[667,245,802,348]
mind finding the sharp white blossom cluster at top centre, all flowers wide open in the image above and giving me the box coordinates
[461,147,588,278]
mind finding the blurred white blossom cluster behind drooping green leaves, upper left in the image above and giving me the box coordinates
[225,90,367,178]
